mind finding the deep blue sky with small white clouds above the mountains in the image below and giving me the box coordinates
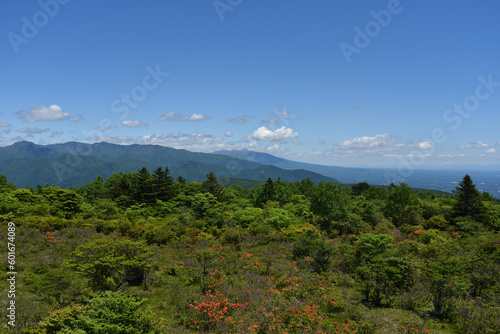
[0,0,500,167]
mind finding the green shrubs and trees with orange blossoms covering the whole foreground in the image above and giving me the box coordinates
[0,167,500,334]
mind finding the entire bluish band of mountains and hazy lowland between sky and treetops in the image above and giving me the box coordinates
[0,141,500,198]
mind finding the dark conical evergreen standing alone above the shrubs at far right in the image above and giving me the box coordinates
[452,174,489,224]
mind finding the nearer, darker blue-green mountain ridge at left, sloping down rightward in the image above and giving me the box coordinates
[0,141,338,187]
